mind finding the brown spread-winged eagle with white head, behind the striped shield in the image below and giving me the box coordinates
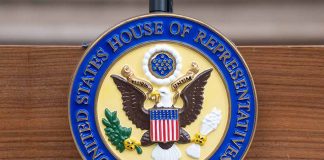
[111,69,213,157]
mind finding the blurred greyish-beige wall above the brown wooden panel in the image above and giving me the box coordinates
[0,0,324,45]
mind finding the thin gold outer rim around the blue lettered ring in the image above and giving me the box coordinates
[68,13,258,159]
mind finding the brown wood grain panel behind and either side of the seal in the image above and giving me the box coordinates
[0,46,324,159]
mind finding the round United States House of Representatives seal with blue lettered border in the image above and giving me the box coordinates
[69,14,257,160]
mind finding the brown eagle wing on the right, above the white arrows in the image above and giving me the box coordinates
[179,69,213,127]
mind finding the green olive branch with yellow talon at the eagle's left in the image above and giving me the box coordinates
[102,108,142,154]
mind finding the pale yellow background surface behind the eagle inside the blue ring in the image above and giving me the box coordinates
[96,42,229,160]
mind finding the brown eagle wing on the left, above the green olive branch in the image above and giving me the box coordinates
[111,75,150,130]
